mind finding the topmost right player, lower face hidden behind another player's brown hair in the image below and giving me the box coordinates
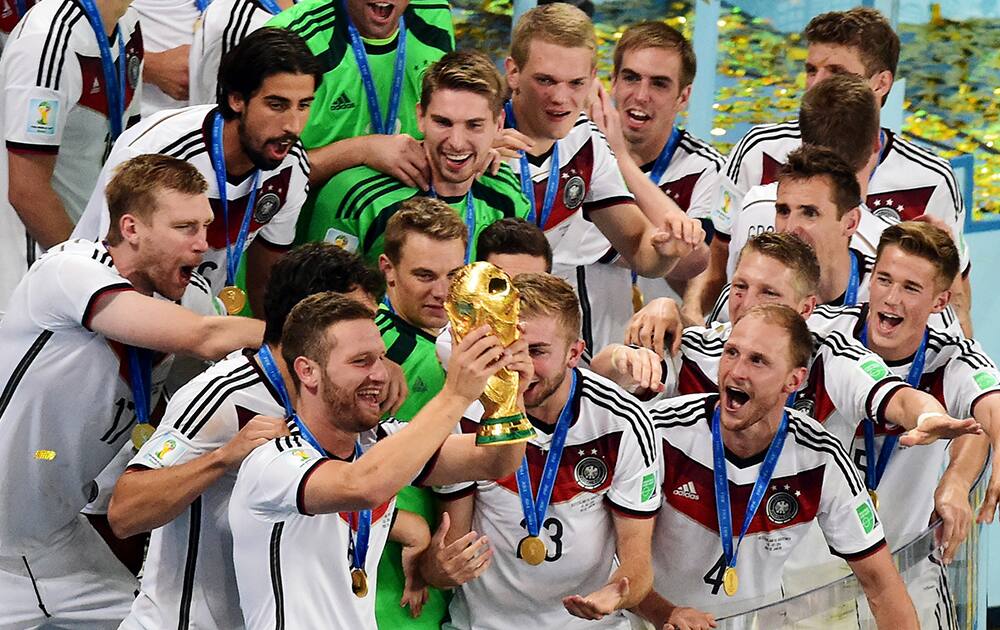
[713,7,972,334]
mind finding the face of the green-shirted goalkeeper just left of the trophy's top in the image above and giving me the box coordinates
[379,232,465,332]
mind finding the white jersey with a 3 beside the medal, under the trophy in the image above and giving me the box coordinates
[442,370,660,630]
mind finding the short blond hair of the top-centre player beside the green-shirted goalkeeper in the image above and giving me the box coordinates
[510,2,597,68]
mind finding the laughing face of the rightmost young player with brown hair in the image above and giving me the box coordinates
[868,245,951,360]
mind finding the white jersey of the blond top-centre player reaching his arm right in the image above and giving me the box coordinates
[507,113,635,267]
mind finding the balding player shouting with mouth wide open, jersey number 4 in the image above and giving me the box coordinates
[638,304,920,629]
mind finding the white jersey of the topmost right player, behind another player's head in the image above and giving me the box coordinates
[716,120,969,269]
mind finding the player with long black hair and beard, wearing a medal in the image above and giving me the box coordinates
[74,29,322,316]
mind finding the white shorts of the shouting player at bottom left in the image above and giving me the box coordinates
[0,515,139,630]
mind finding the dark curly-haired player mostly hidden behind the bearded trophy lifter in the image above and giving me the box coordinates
[108,243,385,630]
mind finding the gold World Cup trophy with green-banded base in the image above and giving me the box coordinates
[444,262,535,446]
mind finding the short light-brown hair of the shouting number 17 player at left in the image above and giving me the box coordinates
[104,153,208,245]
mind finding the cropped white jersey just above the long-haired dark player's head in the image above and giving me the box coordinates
[188,0,274,105]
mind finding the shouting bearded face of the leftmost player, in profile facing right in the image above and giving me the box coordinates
[131,190,214,300]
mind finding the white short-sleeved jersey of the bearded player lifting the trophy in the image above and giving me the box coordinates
[229,421,434,630]
